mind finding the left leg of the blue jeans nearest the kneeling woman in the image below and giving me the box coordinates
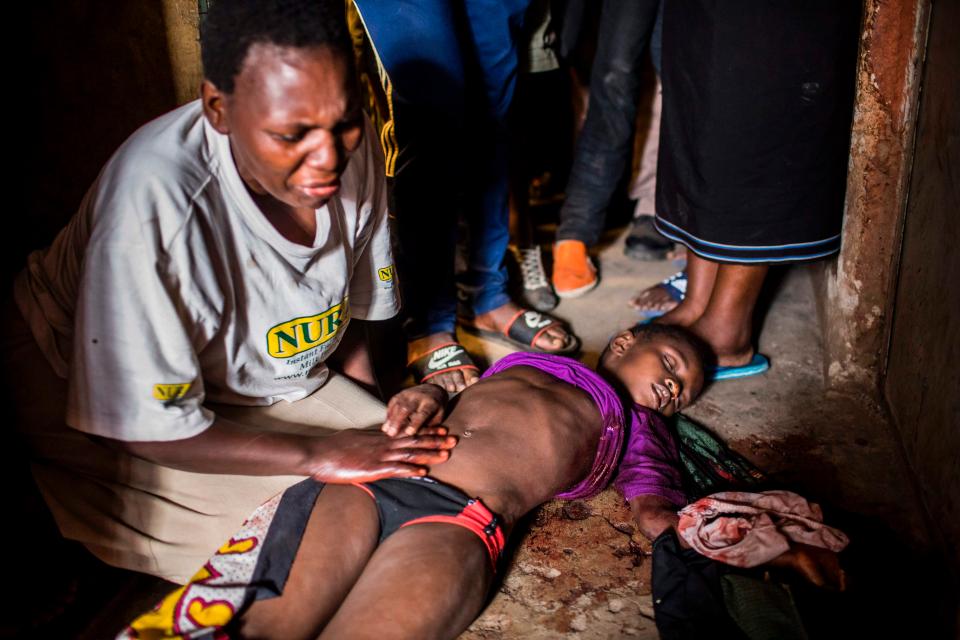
[356,0,465,339]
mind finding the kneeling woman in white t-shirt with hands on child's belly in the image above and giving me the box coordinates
[4,0,446,582]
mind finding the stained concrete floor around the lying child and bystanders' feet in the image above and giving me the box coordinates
[454,230,939,640]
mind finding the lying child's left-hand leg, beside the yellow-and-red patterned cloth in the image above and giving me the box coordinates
[239,485,380,640]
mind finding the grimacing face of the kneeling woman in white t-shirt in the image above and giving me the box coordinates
[203,44,363,209]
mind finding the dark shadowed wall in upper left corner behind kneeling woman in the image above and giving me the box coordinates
[8,0,176,278]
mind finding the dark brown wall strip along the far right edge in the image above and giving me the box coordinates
[885,2,960,569]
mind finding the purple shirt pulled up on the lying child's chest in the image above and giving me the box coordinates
[483,353,687,506]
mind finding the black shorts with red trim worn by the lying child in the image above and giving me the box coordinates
[354,478,506,570]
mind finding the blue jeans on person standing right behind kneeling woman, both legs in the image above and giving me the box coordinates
[356,0,530,338]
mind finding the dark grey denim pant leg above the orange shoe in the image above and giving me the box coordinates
[557,0,659,245]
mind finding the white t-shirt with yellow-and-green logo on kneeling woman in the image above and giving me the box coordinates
[15,101,400,441]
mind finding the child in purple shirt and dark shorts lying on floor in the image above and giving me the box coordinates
[121,325,832,639]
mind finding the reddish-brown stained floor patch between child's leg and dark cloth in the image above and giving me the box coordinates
[461,490,658,640]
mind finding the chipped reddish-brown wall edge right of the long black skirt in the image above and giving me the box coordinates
[816,0,929,400]
